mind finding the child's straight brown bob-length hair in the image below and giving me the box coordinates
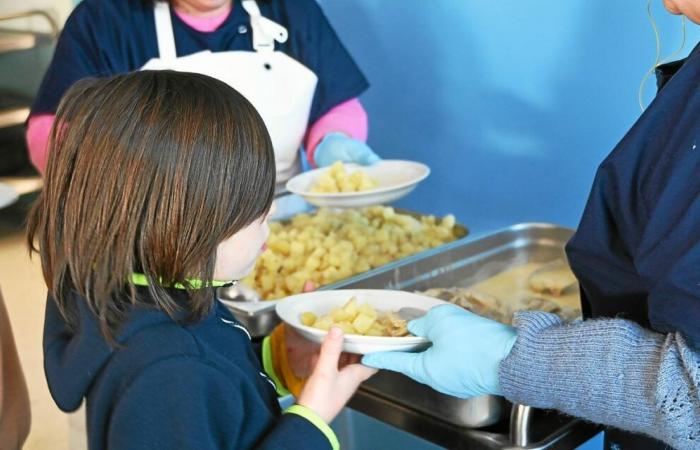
[27,71,275,341]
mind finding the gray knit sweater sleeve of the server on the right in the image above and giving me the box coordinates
[500,312,700,449]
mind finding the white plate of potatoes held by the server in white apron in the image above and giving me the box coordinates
[286,159,430,208]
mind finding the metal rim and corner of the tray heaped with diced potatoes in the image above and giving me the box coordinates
[217,208,469,338]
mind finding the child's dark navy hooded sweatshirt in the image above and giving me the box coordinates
[44,288,331,450]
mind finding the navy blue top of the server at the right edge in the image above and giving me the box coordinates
[567,42,700,348]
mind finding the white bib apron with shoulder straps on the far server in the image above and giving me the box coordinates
[141,0,318,186]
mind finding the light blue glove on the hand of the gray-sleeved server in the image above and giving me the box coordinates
[362,305,516,398]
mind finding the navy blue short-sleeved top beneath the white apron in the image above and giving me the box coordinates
[32,0,368,123]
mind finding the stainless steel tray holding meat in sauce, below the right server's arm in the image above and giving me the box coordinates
[323,224,573,428]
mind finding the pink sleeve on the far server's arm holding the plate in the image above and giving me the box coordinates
[305,98,368,167]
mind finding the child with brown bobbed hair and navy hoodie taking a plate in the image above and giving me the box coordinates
[28,71,373,449]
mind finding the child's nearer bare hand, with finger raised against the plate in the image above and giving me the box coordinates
[297,327,376,423]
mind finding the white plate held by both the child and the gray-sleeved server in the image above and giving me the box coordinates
[276,289,446,355]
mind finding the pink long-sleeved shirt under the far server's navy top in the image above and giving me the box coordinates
[26,3,369,174]
